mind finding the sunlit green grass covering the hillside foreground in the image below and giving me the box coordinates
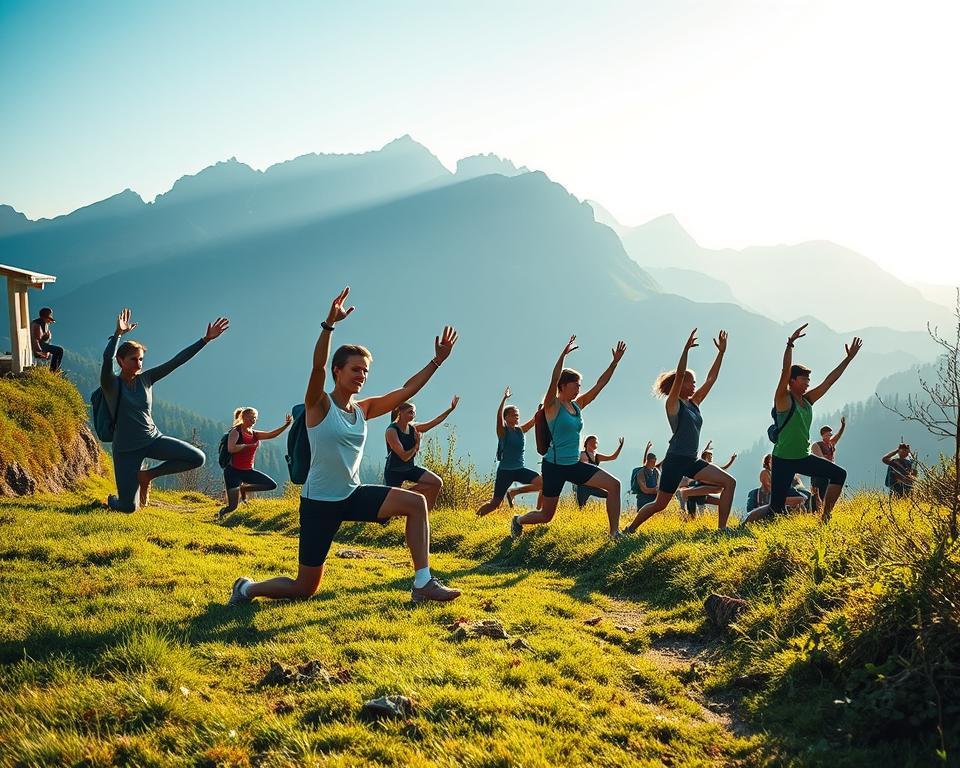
[0,480,953,768]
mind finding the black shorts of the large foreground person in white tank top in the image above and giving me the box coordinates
[300,485,390,568]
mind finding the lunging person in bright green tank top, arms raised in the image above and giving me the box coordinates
[744,323,863,523]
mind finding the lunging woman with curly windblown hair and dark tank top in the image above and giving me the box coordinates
[626,328,737,533]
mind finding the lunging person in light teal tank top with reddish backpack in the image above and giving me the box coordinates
[510,336,627,538]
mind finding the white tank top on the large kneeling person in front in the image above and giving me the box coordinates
[300,395,367,501]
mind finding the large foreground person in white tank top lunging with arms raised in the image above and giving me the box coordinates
[229,288,460,605]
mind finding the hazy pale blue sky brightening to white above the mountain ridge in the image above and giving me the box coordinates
[0,0,960,282]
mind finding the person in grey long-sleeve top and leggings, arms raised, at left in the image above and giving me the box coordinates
[100,309,230,512]
